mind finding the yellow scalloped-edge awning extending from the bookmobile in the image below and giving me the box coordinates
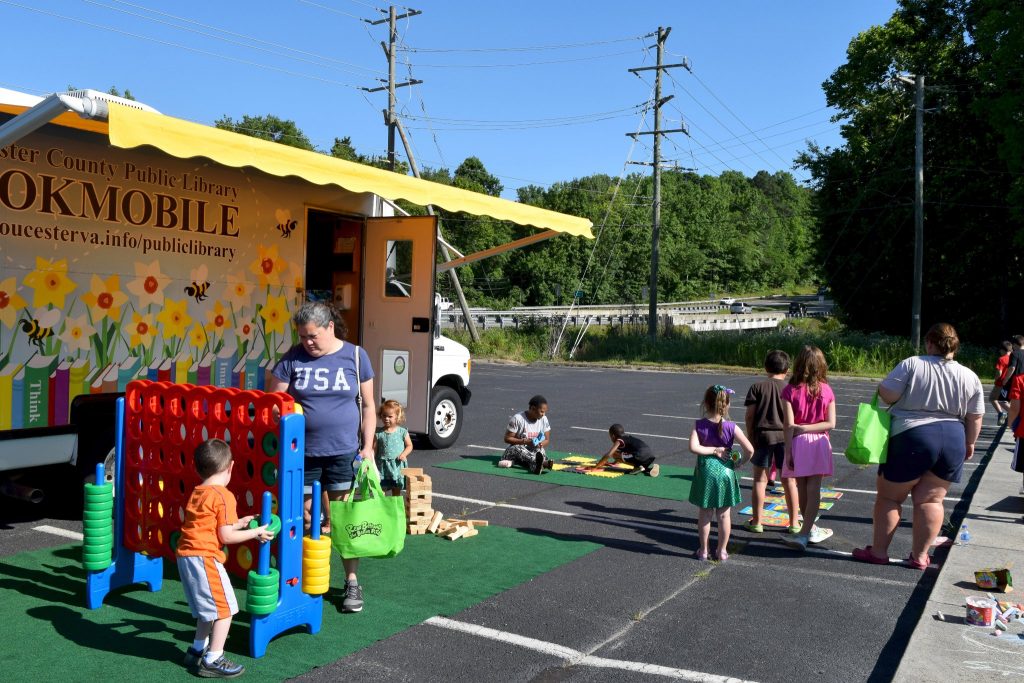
[109,102,594,239]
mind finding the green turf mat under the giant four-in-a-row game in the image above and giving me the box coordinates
[0,526,599,683]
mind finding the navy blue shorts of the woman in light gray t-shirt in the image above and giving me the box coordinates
[879,420,967,483]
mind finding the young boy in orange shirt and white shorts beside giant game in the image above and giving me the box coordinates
[175,438,273,678]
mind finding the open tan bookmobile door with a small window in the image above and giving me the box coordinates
[360,216,437,433]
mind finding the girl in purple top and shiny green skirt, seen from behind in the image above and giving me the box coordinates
[689,384,754,562]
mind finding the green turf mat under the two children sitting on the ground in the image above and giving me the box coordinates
[434,451,693,501]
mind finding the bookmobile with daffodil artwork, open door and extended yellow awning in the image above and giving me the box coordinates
[0,88,591,502]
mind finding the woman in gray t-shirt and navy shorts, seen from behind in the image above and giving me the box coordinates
[853,323,985,569]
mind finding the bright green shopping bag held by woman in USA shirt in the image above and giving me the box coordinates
[331,460,406,559]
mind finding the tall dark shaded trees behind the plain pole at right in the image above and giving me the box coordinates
[800,0,1024,341]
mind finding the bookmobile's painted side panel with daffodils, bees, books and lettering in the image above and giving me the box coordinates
[0,129,306,429]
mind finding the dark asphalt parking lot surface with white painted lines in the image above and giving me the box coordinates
[0,362,991,681]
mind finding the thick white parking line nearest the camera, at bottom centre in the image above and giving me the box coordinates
[424,616,761,683]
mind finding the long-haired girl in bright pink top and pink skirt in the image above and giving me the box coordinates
[781,346,836,550]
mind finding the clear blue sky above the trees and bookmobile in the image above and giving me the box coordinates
[0,0,896,197]
